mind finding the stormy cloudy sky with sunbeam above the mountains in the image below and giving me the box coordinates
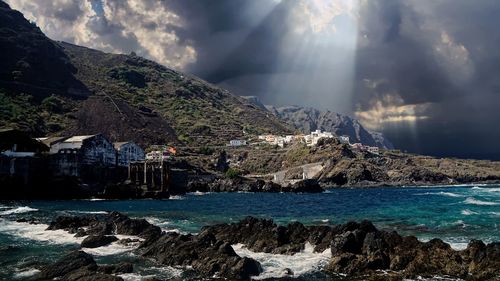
[7,0,500,160]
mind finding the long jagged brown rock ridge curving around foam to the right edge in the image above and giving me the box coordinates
[200,217,500,280]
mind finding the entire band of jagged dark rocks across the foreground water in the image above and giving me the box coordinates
[29,212,500,280]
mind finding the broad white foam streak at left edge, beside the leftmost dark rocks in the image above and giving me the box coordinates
[0,219,83,244]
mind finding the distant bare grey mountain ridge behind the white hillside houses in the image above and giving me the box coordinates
[266,106,394,149]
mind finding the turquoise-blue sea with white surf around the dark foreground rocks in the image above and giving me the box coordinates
[0,185,500,280]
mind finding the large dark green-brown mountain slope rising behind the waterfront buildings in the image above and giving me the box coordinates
[0,1,293,145]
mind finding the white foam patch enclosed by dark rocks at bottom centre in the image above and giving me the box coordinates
[233,243,332,279]
